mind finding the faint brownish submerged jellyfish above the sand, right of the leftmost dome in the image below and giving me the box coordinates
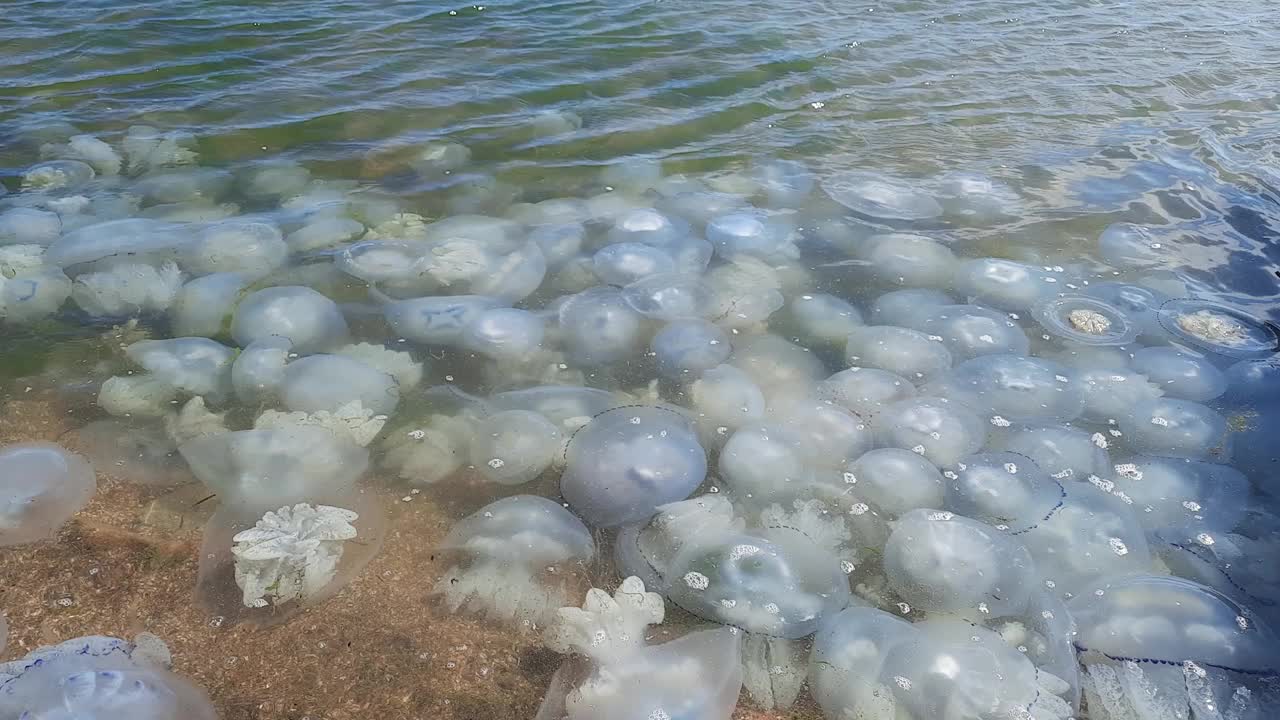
[67,419,191,487]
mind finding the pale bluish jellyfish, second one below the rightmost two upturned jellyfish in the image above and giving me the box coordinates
[1117,397,1231,462]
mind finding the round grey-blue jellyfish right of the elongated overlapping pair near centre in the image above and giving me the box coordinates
[559,287,645,366]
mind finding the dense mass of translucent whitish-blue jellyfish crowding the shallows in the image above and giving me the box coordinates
[0,128,1280,720]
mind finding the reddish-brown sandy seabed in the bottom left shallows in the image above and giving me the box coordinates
[0,393,822,720]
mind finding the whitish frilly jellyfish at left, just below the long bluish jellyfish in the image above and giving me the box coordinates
[70,261,183,318]
